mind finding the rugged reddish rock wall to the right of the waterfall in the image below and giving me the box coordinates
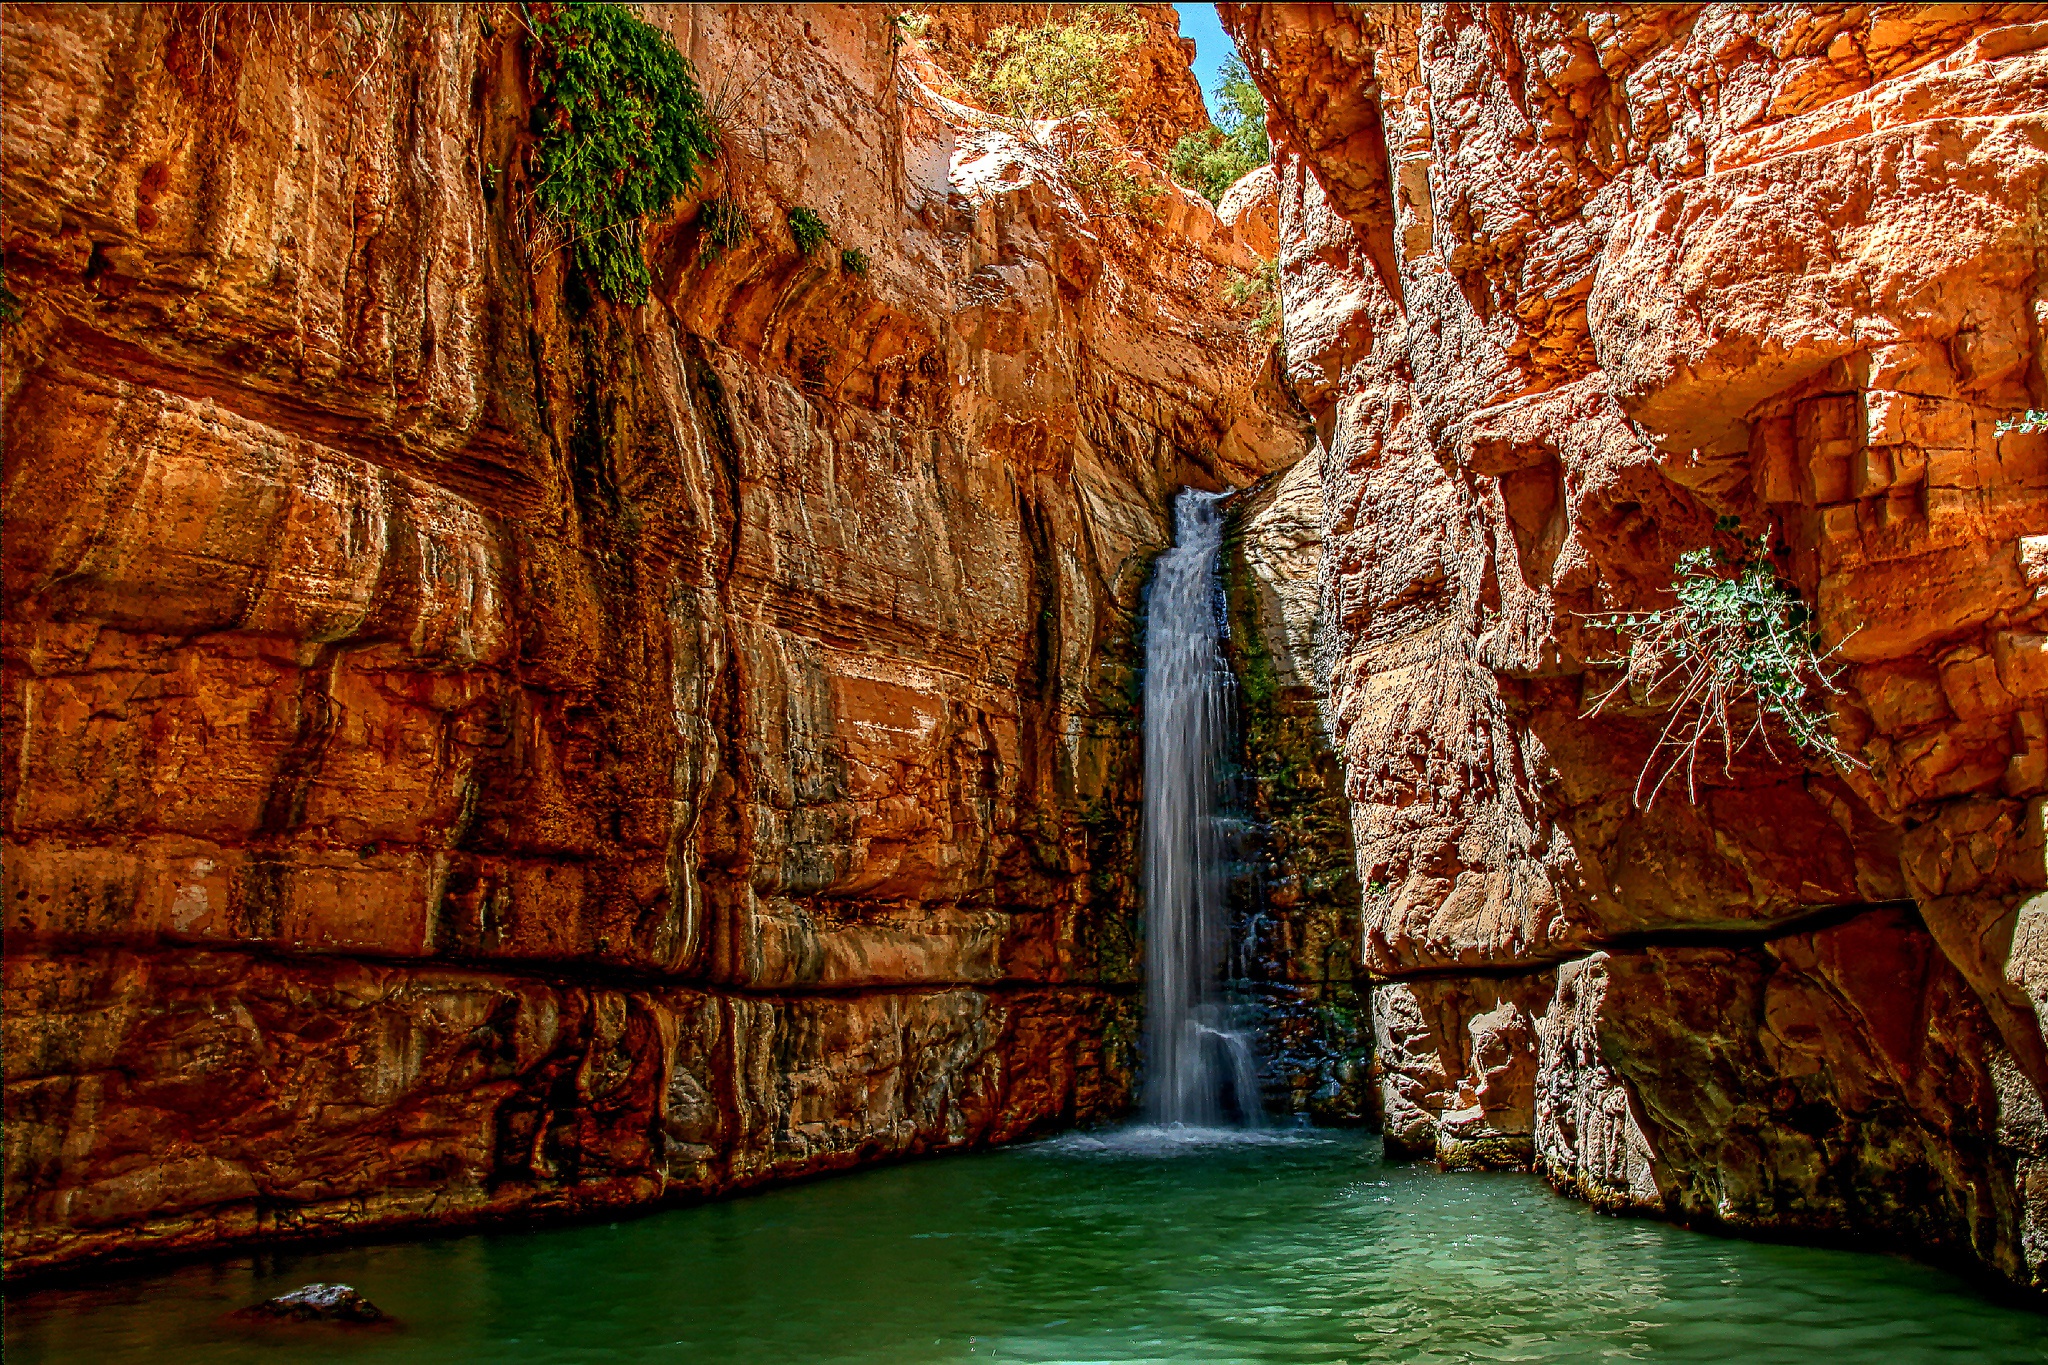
[1221,4,2048,1287]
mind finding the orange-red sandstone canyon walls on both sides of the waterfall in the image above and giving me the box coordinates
[12,4,2048,1309]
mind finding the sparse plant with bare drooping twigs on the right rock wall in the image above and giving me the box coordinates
[1585,518,1855,810]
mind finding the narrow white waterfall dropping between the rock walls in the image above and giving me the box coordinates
[1141,489,1260,1128]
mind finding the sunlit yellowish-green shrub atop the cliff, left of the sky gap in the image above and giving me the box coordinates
[958,4,1139,121]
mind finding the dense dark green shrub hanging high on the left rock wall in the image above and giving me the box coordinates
[530,4,719,305]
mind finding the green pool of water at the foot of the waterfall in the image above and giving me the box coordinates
[6,1130,2048,1365]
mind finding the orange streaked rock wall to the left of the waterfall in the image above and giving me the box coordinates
[0,6,1303,1271]
